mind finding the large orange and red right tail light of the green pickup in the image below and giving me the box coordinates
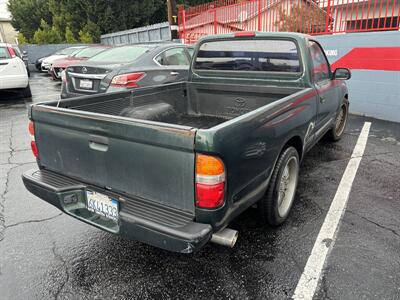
[196,154,225,208]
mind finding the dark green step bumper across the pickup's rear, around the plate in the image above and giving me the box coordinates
[22,169,212,253]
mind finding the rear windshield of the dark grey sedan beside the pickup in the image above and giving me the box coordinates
[89,46,150,63]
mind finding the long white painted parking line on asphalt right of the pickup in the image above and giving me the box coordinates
[293,122,371,300]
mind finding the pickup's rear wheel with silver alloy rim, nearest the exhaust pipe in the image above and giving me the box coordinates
[257,147,300,226]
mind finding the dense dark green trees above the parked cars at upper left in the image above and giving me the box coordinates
[8,0,216,43]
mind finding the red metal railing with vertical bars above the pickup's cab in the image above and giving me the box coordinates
[178,0,400,43]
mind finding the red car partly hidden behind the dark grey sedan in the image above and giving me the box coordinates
[49,45,111,80]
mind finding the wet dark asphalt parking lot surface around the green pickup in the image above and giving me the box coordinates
[0,73,400,299]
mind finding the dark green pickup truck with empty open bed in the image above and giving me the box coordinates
[23,32,351,253]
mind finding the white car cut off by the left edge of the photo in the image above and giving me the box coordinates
[0,43,32,98]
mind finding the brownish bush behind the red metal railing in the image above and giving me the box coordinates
[275,2,326,33]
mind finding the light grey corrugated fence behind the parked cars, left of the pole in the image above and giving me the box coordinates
[101,22,171,46]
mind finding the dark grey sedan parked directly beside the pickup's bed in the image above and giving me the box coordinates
[61,43,195,98]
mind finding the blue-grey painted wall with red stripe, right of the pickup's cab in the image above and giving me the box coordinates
[315,31,400,122]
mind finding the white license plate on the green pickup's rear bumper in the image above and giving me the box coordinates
[86,190,119,222]
